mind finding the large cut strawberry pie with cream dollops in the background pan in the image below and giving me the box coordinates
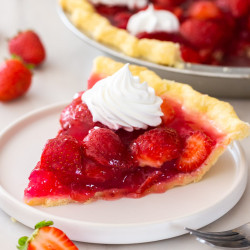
[60,0,250,67]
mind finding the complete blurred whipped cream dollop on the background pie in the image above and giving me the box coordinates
[127,4,180,35]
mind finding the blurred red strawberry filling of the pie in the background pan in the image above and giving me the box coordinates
[94,0,250,67]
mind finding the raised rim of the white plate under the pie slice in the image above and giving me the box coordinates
[0,102,248,244]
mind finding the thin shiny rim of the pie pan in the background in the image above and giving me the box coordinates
[56,4,250,79]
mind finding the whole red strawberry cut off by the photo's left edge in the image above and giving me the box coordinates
[0,59,32,102]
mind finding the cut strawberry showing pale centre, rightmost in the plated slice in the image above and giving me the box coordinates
[177,131,213,172]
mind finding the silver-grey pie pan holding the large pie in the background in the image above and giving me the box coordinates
[57,6,250,98]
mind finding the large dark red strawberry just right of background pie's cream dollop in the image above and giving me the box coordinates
[180,19,225,48]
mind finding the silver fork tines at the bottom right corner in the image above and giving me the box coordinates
[185,222,250,249]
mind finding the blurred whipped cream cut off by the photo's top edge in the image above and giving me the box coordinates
[90,0,148,9]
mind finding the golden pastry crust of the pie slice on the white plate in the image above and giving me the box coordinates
[24,57,250,206]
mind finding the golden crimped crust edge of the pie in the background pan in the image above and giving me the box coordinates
[59,0,183,68]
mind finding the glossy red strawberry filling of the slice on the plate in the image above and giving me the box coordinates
[24,75,223,203]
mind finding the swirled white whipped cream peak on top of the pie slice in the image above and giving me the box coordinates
[82,64,163,132]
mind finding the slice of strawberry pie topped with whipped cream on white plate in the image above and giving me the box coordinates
[24,57,250,206]
